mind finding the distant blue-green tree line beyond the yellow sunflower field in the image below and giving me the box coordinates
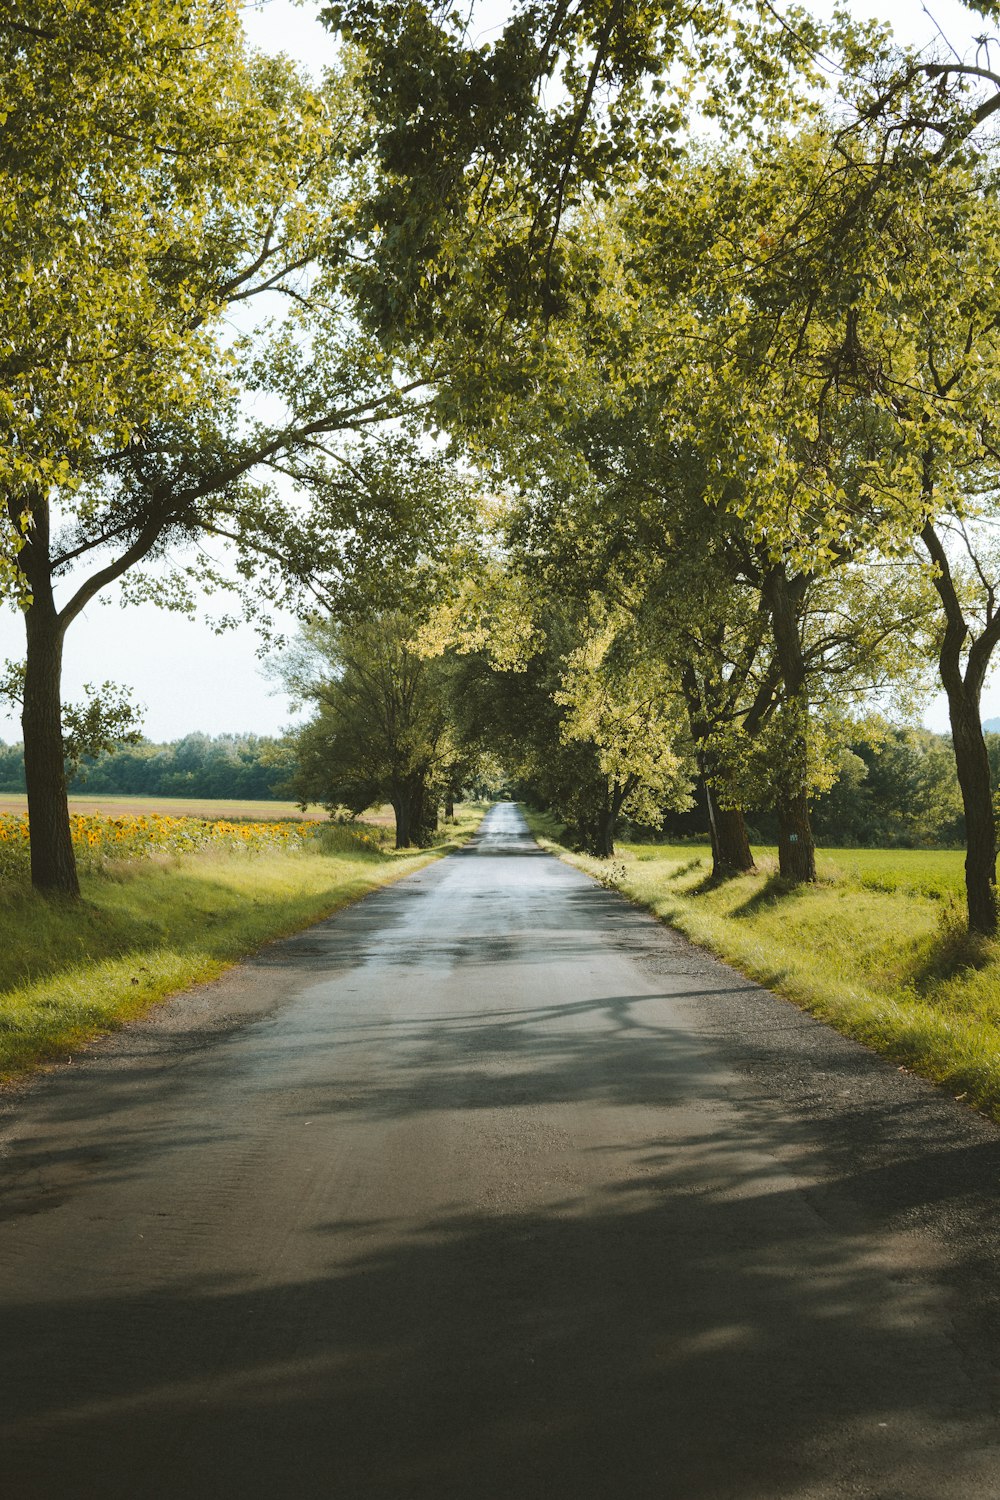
[0,734,295,801]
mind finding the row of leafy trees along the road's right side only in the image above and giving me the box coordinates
[313,0,1000,933]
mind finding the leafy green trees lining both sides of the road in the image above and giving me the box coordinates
[13,0,1000,933]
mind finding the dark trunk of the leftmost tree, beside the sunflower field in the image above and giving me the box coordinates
[21,603,79,897]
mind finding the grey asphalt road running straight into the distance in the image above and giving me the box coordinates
[0,806,1000,1500]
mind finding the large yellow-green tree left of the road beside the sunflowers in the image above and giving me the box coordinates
[0,0,446,896]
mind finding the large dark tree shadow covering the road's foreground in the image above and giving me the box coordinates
[0,1086,1000,1500]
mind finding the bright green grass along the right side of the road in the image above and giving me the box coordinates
[526,812,1000,1121]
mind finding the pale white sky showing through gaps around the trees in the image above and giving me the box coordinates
[0,0,1000,743]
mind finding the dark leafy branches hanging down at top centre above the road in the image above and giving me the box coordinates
[321,0,839,348]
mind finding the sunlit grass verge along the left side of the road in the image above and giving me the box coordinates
[0,803,484,1083]
